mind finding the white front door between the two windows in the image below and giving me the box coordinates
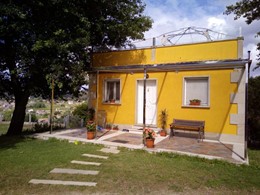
[136,80,157,125]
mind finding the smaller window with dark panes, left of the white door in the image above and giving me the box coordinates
[103,79,120,103]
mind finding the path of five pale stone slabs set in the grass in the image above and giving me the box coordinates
[29,147,120,186]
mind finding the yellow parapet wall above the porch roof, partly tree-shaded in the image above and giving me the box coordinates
[93,39,239,67]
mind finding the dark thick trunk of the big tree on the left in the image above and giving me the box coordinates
[7,94,29,136]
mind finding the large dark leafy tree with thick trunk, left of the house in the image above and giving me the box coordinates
[0,0,152,135]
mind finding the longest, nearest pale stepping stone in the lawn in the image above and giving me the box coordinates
[29,179,97,186]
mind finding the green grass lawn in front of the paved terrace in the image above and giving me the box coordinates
[0,136,260,195]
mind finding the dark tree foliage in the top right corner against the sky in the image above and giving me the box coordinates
[224,0,260,69]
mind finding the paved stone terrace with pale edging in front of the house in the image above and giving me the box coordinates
[33,128,247,163]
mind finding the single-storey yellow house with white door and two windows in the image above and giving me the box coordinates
[89,37,248,160]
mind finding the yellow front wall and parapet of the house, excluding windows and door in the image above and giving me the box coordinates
[89,38,246,146]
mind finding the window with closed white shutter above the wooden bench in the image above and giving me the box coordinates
[183,77,209,106]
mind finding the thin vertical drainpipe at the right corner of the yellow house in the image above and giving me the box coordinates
[244,51,252,159]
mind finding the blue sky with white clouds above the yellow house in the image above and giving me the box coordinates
[140,0,260,76]
